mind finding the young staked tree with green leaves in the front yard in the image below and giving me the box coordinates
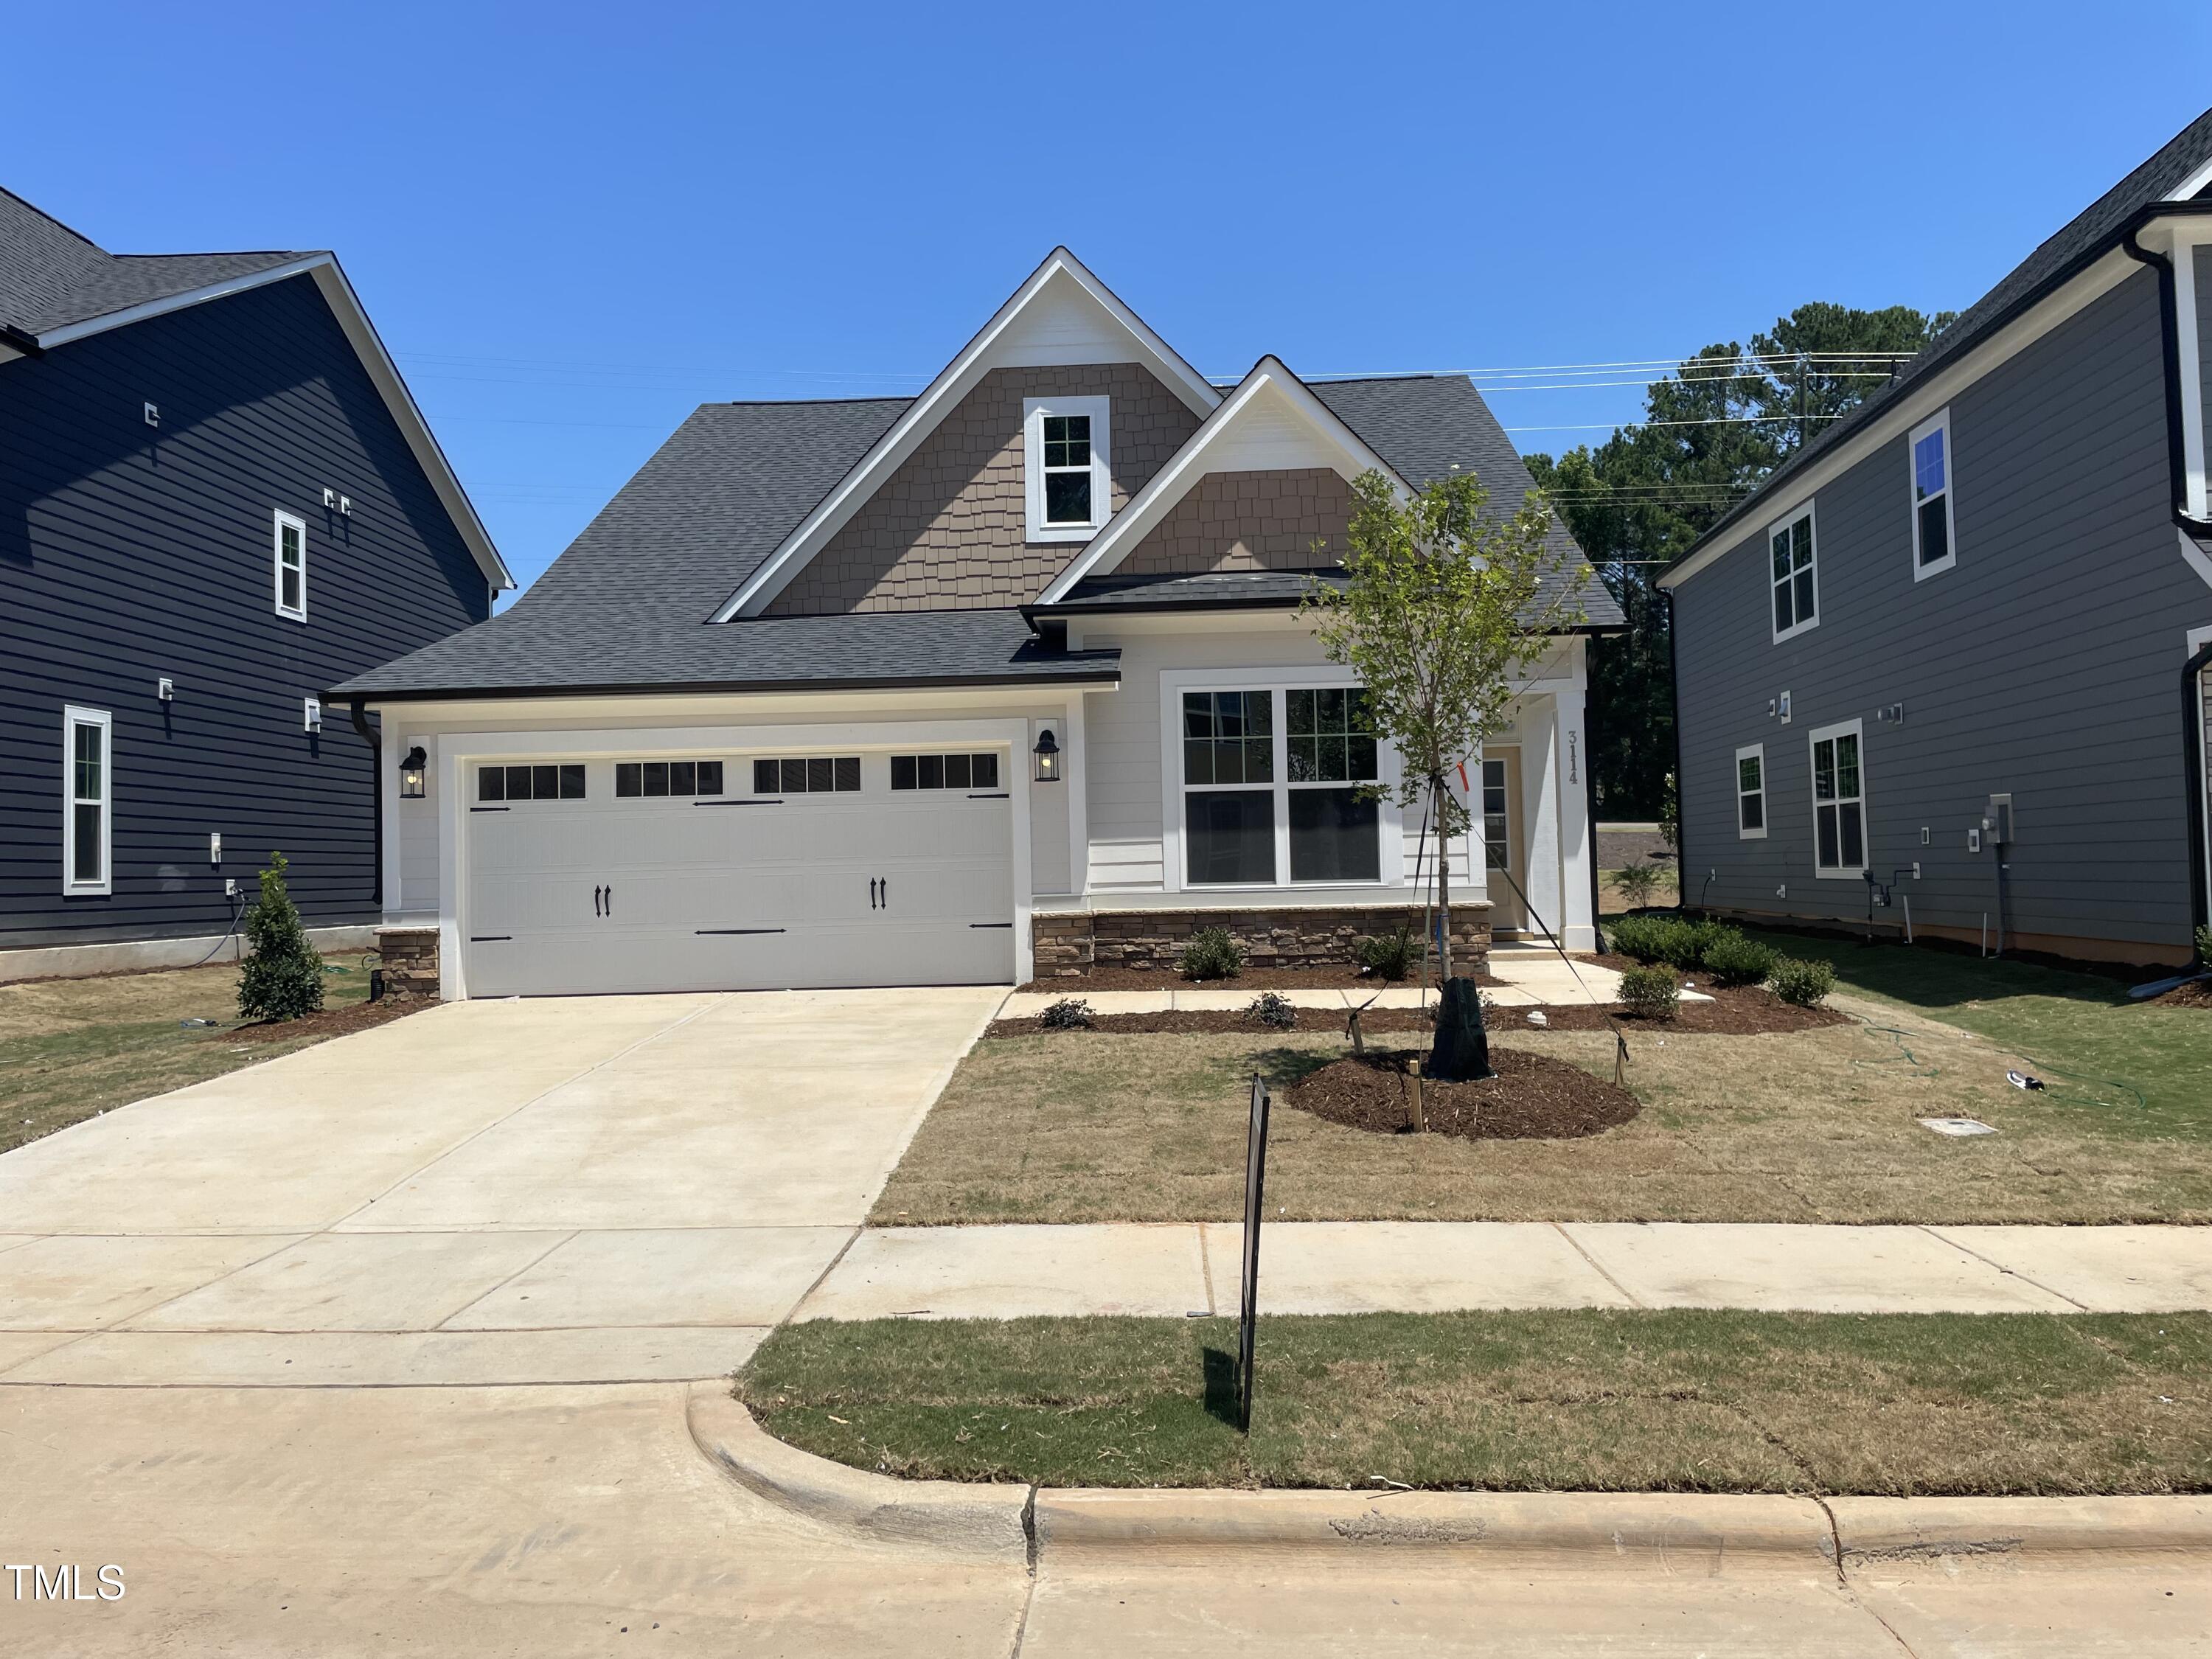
[1301,471,1590,1082]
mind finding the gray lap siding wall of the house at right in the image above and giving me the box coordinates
[1674,272,2212,956]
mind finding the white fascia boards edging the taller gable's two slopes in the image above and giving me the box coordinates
[708,248,1221,622]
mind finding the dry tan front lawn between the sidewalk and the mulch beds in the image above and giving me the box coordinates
[872,1004,2212,1225]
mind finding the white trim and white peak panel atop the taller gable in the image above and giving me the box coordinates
[710,248,1221,622]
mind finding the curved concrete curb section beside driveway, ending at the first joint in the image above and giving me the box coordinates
[686,1380,1031,1562]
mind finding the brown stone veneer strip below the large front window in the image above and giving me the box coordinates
[1031,900,1491,980]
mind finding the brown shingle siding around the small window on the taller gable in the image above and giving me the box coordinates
[765,363,1199,617]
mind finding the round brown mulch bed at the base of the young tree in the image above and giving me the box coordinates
[1283,1046,1641,1141]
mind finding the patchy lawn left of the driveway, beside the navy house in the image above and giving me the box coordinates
[0,951,387,1152]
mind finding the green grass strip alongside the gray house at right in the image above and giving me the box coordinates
[1745,929,2212,1139]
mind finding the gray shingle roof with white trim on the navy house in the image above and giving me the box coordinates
[0,190,515,588]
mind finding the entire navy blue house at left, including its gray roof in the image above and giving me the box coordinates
[0,190,511,978]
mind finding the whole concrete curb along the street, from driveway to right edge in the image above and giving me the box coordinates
[688,1407,2212,1579]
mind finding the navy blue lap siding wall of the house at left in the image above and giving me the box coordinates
[0,276,491,945]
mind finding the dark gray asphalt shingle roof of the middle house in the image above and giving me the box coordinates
[334,363,1619,697]
